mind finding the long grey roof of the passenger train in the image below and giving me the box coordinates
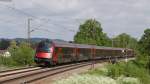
[52,40,131,50]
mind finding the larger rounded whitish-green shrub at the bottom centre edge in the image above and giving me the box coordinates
[54,74,116,84]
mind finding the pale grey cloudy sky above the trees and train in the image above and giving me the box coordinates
[0,0,150,41]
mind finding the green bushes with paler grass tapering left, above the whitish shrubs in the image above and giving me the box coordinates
[86,60,150,84]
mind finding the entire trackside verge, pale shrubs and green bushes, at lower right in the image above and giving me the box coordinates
[54,61,150,84]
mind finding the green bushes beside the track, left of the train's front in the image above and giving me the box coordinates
[0,42,34,66]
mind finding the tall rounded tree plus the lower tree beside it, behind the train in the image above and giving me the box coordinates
[74,19,138,49]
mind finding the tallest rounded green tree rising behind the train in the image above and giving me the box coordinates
[74,19,110,46]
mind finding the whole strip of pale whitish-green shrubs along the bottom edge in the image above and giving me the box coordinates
[54,74,140,84]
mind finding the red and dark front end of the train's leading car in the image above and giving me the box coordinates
[34,40,53,65]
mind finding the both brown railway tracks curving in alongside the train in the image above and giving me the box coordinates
[0,59,133,84]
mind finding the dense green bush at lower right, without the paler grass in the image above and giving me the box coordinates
[108,61,150,84]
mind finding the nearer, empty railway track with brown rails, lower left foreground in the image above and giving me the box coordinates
[0,62,91,84]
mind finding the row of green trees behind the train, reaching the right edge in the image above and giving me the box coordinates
[74,19,150,55]
